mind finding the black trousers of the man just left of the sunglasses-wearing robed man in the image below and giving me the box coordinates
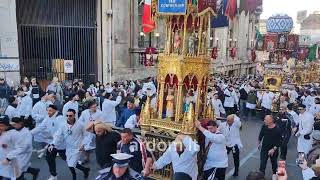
[46,148,67,176]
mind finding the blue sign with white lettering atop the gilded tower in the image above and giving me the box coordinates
[158,0,187,15]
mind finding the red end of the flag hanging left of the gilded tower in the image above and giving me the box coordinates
[142,0,155,33]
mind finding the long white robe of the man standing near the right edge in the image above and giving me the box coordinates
[297,112,314,154]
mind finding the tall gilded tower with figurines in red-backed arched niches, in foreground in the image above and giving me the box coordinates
[140,0,215,136]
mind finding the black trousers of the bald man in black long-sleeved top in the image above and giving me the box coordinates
[259,150,279,174]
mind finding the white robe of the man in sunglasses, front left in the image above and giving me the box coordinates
[53,120,88,167]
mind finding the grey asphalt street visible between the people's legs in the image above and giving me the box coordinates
[27,113,302,180]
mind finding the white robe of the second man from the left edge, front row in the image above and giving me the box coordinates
[7,128,32,172]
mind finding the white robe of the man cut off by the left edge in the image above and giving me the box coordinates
[0,130,19,180]
